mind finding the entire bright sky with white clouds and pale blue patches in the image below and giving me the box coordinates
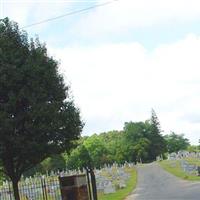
[0,0,200,144]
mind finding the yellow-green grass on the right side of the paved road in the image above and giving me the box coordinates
[158,159,200,181]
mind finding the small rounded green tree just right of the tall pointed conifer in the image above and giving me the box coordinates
[164,132,191,153]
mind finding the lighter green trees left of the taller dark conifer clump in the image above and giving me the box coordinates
[66,131,133,169]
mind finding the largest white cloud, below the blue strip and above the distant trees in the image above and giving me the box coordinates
[48,35,200,143]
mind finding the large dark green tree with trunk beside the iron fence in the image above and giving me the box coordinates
[0,18,82,200]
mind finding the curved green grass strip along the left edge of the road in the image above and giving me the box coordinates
[98,168,137,200]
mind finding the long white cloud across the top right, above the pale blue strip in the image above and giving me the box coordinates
[72,0,200,38]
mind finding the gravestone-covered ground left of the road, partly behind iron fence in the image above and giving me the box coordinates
[0,163,134,200]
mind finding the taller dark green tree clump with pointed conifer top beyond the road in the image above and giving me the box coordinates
[124,110,166,162]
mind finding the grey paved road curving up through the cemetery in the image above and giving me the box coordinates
[126,163,200,200]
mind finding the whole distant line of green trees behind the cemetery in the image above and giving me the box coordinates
[15,110,197,175]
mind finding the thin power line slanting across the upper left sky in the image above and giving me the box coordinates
[20,0,118,29]
